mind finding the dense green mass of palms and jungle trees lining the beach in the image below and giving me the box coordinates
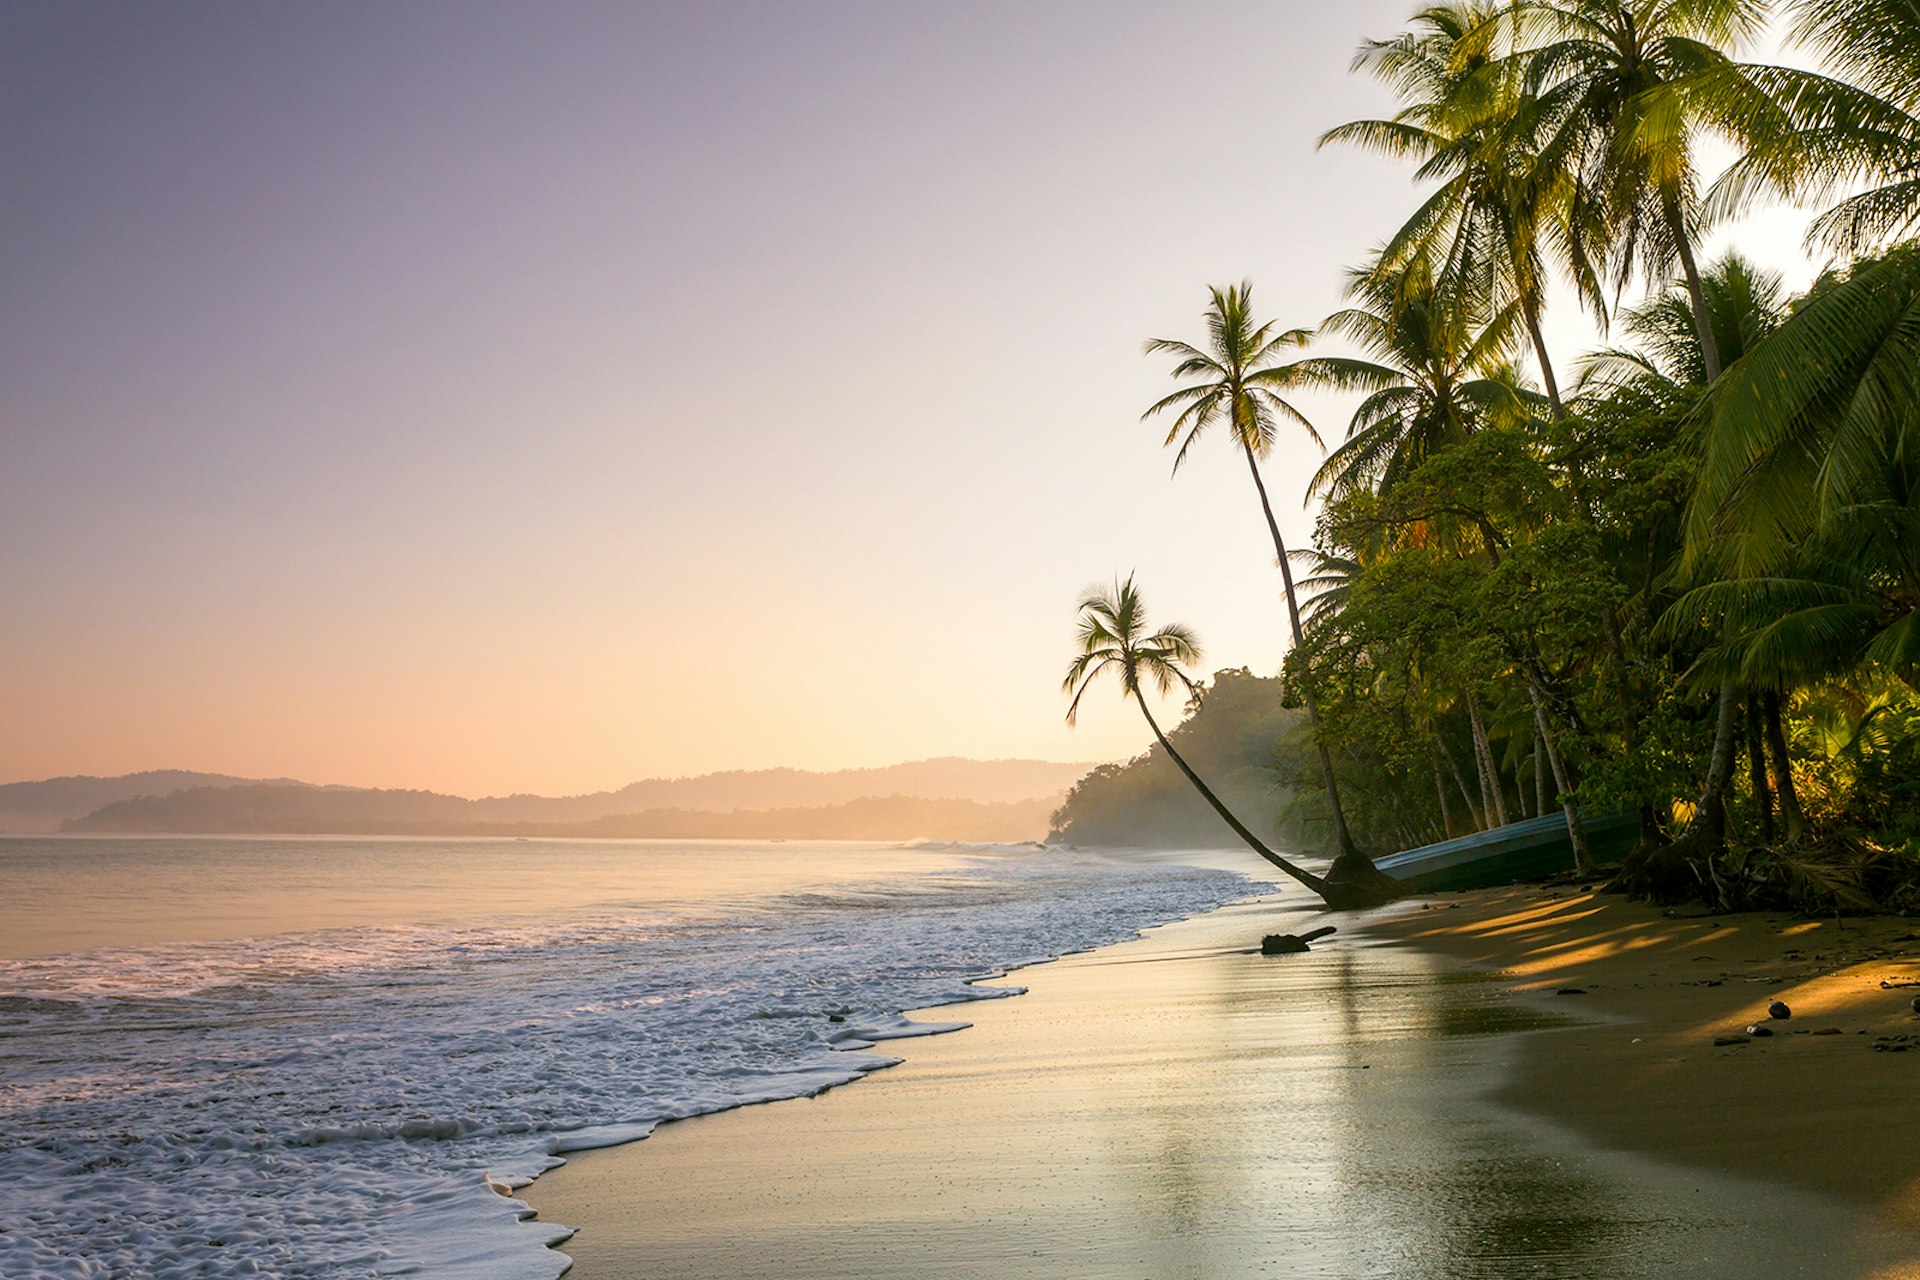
[1075,0,1920,910]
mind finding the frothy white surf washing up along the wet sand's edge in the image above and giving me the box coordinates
[0,850,1248,1280]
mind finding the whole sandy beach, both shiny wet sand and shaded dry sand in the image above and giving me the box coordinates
[524,889,1920,1280]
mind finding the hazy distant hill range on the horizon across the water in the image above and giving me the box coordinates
[0,756,1089,841]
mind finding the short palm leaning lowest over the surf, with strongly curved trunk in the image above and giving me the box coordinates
[1060,574,1404,910]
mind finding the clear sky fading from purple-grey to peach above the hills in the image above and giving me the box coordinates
[0,0,1811,794]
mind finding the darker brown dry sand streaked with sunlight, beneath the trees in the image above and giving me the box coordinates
[1375,889,1920,1230]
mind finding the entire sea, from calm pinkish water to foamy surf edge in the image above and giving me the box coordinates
[0,839,1254,1280]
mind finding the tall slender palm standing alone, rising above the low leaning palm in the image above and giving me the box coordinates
[1140,280,1380,887]
